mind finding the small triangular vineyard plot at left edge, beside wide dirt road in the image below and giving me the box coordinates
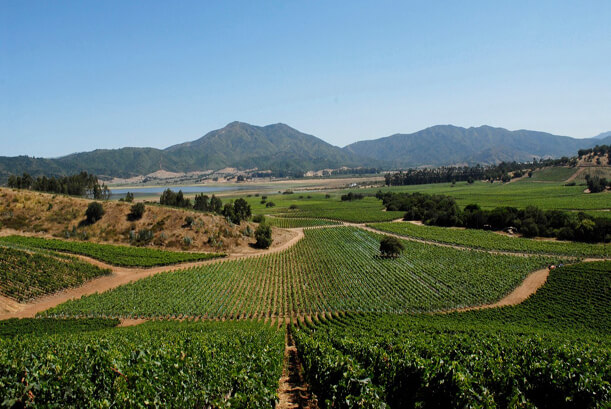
[0,246,110,302]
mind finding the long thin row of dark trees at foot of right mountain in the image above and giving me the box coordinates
[384,156,577,186]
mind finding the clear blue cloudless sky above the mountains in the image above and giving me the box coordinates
[0,0,611,157]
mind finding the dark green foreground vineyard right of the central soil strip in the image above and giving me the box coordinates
[294,262,611,408]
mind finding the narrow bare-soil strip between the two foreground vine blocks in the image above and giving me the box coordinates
[276,326,317,409]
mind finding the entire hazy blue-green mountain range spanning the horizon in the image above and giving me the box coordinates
[0,122,611,181]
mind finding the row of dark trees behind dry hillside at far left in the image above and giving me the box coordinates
[7,172,110,200]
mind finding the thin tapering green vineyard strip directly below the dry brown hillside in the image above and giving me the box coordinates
[0,236,224,267]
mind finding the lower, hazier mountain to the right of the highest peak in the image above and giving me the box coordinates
[344,125,604,167]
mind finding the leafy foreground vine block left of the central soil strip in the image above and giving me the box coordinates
[0,322,284,408]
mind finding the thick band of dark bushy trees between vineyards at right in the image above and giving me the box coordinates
[376,191,611,242]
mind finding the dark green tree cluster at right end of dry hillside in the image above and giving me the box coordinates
[159,189,252,224]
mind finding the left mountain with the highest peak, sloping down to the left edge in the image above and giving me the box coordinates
[0,122,376,181]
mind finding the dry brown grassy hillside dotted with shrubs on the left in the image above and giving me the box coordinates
[0,188,256,252]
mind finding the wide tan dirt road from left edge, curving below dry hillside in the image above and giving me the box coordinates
[0,230,304,320]
